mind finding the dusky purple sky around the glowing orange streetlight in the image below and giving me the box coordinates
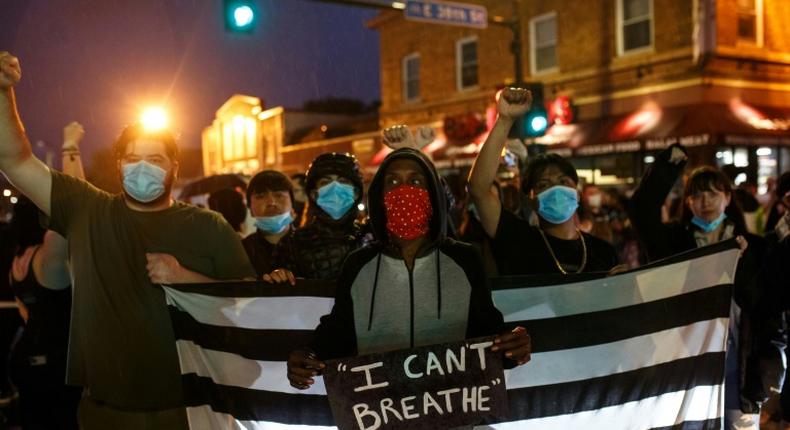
[0,0,379,163]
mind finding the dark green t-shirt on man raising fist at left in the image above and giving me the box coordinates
[49,171,255,411]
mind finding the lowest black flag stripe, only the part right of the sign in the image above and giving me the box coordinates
[503,352,724,421]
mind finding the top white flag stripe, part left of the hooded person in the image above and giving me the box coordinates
[163,287,335,330]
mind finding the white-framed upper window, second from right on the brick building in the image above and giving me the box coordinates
[617,0,653,55]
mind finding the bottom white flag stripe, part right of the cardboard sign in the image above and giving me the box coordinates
[488,385,724,430]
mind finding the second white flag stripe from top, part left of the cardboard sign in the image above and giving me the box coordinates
[176,340,326,396]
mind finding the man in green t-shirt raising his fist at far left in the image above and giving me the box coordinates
[0,52,255,430]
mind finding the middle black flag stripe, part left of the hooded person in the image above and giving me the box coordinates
[168,306,313,361]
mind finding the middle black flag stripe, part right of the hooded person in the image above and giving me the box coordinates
[508,284,732,353]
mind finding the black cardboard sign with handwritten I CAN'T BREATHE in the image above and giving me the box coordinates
[324,337,507,430]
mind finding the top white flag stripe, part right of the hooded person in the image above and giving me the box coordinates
[493,249,740,322]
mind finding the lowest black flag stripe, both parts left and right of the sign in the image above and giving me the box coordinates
[182,352,724,430]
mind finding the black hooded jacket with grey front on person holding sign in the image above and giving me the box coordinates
[310,149,504,359]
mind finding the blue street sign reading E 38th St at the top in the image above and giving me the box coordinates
[403,0,488,28]
